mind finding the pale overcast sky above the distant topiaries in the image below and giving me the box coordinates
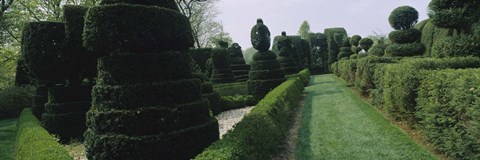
[217,0,430,49]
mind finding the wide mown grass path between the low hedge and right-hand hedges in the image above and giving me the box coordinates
[295,74,436,160]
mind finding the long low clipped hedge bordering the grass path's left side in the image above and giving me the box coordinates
[195,78,304,160]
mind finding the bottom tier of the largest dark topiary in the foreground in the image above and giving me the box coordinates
[85,117,219,160]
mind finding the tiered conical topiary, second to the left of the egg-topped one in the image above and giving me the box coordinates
[210,47,236,83]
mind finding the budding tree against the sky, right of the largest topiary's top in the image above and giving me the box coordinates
[175,0,229,48]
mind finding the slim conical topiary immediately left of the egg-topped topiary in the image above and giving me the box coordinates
[228,43,250,82]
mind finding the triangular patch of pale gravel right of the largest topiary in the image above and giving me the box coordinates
[215,106,253,139]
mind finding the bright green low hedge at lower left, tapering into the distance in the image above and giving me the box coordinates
[15,108,73,160]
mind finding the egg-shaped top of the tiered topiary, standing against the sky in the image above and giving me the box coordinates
[250,18,270,52]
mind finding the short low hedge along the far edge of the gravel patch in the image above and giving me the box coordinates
[220,95,257,111]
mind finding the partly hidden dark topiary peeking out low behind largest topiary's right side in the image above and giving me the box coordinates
[193,73,222,115]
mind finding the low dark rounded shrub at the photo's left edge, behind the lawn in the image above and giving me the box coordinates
[0,86,35,119]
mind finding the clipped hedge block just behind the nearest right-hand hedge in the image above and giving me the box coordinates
[383,57,480,122]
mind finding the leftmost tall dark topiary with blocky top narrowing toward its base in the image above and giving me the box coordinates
[22,22,65,119]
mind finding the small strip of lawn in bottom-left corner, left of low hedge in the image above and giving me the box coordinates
[0,119,17,160]
